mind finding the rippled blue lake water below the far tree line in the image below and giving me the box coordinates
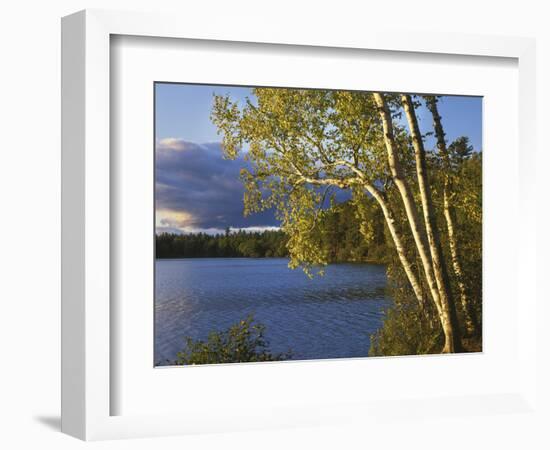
[155,258,391,365]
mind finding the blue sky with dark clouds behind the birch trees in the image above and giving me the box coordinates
[155,83,482,234]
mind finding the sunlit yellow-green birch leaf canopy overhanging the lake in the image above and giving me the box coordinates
[211,88,410,274]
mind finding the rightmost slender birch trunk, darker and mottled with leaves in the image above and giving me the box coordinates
[425,96,478,335]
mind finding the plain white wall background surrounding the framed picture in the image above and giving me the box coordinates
[0,0,550,449]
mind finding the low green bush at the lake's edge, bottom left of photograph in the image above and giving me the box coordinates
[174,316,292,365]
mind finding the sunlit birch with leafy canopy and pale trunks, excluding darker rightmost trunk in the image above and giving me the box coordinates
[212,88,461,352]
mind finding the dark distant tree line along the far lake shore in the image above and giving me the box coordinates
[156,200,387,262]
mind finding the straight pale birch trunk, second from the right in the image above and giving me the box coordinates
[401,94,461,352]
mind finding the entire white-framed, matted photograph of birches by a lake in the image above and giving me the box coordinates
[62,11,536,440]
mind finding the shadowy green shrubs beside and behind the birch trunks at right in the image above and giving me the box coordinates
[369,149,482,356]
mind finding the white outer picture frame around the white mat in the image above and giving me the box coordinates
[62,10,538,440]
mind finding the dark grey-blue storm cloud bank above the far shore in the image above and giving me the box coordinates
[156,138,278,231]
